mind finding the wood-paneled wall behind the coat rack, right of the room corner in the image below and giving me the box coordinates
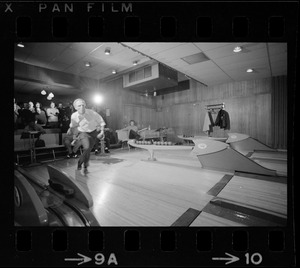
[157,79,271,145]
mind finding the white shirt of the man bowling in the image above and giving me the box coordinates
[70,109,106,132]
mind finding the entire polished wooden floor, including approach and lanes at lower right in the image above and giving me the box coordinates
[27,149,287,226]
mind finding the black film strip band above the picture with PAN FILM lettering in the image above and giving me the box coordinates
[0,1,298,42]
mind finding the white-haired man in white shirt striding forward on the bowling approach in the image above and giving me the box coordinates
[70,99,105,174]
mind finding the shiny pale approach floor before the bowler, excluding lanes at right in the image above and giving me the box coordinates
[22,149,229,226]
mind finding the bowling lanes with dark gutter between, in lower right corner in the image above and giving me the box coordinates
[191,173,287,226]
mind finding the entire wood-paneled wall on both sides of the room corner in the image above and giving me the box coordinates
[100,75,284,146]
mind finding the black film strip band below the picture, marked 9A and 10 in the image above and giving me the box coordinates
[11,228,293,267]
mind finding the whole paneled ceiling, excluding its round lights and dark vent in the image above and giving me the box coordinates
[15,42,287,94]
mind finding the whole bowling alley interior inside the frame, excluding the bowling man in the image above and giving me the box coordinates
[14,42,291,227]
